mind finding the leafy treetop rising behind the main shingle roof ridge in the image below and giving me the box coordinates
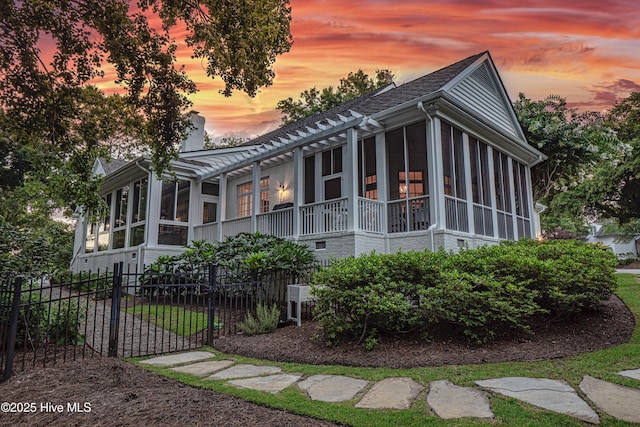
[276,69,393,125]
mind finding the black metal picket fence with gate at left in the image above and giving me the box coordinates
[0,264,320,380]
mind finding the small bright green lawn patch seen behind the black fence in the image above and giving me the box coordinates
[124,304,220,337]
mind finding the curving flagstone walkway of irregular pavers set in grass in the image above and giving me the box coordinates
[140,351,640,424]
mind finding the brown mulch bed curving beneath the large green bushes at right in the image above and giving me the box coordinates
[214,296,635,368]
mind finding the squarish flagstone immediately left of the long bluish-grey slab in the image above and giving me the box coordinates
[427,380,493,419]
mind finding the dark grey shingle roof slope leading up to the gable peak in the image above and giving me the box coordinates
[243,52,486,145]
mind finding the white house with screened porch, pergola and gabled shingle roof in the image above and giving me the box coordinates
[72,52,545,271]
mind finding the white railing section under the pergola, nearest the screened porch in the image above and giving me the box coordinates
[300,198,349,235]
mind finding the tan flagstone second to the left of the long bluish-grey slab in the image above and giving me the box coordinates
[356,377,424,409]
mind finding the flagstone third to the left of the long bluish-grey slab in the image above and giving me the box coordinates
[298,375,369,402]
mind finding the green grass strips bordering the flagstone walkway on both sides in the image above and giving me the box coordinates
[134,274,640,427]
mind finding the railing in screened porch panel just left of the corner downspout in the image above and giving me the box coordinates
[387,196,431,233]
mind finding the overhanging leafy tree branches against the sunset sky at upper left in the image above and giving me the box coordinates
[0,0,291,214]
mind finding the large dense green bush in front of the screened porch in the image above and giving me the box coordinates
[311,240,616,348]
